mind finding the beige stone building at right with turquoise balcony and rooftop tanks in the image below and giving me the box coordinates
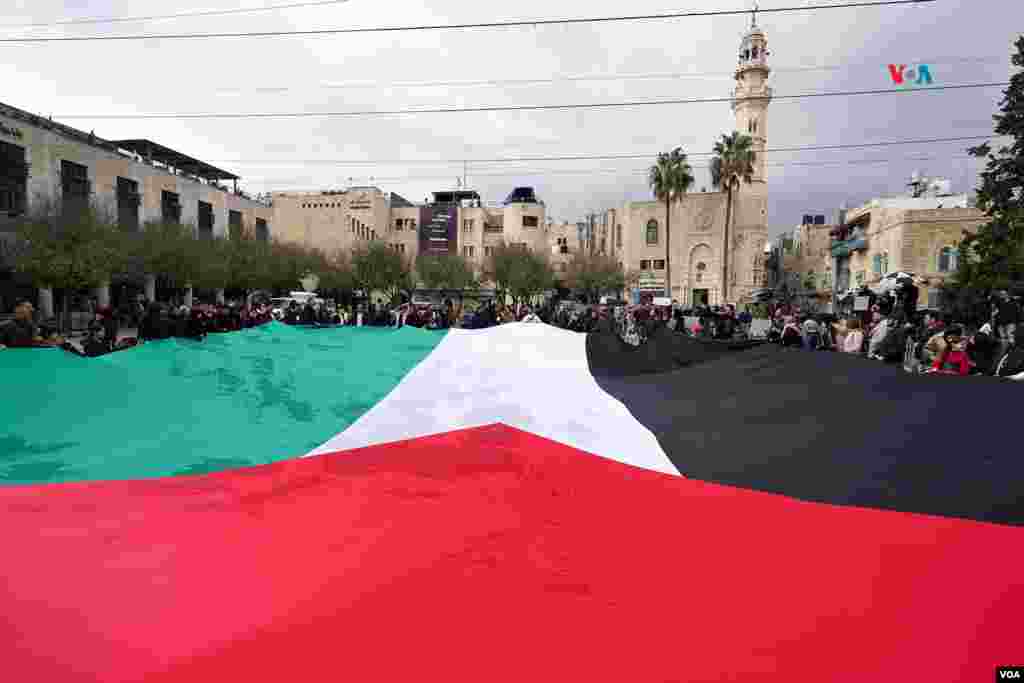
[826,174,987,308]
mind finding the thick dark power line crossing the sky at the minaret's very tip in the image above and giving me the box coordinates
[0,0,935,43]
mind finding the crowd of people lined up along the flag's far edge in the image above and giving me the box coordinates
[6,282,1024,376]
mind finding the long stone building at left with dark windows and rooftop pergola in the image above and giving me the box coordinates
[0,99,272,314]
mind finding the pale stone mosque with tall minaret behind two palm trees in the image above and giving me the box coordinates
[592,17,772,305]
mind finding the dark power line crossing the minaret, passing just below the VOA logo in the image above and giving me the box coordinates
[58,82,1009,121]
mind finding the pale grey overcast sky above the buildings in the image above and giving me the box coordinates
[0,0,1024,233]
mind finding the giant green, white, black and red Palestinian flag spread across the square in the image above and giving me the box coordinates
[0,324,1024,682]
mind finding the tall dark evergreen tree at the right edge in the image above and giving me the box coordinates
[945,36,1024,296]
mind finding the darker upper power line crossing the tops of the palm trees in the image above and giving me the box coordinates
[209,133,998,166]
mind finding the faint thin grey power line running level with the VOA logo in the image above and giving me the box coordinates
[214,55,1006,94]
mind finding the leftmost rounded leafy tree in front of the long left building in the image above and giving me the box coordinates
[11,202,125,325]
